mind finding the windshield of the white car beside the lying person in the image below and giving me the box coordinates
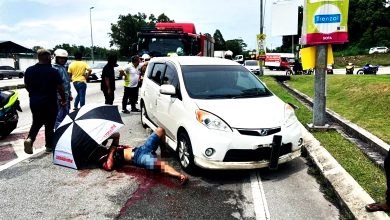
[182,65,272,99]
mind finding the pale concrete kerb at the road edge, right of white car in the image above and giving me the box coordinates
[302,126,390,220]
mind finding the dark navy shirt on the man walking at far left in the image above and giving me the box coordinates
[24,63,63,108]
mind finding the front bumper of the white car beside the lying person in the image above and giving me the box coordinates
[188,121,303,169]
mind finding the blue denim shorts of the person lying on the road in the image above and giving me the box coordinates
[132,132,161,170]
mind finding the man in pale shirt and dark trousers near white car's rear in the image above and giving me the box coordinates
[122,55,141,114]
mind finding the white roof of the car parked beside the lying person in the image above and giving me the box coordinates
[151,56,241,66]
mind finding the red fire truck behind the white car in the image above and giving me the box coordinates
[135,22,214,57]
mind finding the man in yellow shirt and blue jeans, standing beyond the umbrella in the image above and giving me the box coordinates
[68,52,92,110]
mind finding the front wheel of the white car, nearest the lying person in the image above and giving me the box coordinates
[177,132,195,173]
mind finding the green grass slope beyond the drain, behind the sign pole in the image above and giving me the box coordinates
[288,75,390,143]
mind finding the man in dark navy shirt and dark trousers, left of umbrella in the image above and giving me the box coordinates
[24,49,66,154]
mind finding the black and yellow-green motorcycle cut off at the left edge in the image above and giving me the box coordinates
[0,90,22,137]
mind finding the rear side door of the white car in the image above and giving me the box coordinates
[143,63,166,124]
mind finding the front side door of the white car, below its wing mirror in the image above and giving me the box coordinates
[156,63,183,140]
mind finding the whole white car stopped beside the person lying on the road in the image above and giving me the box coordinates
[140,57,303,171]
